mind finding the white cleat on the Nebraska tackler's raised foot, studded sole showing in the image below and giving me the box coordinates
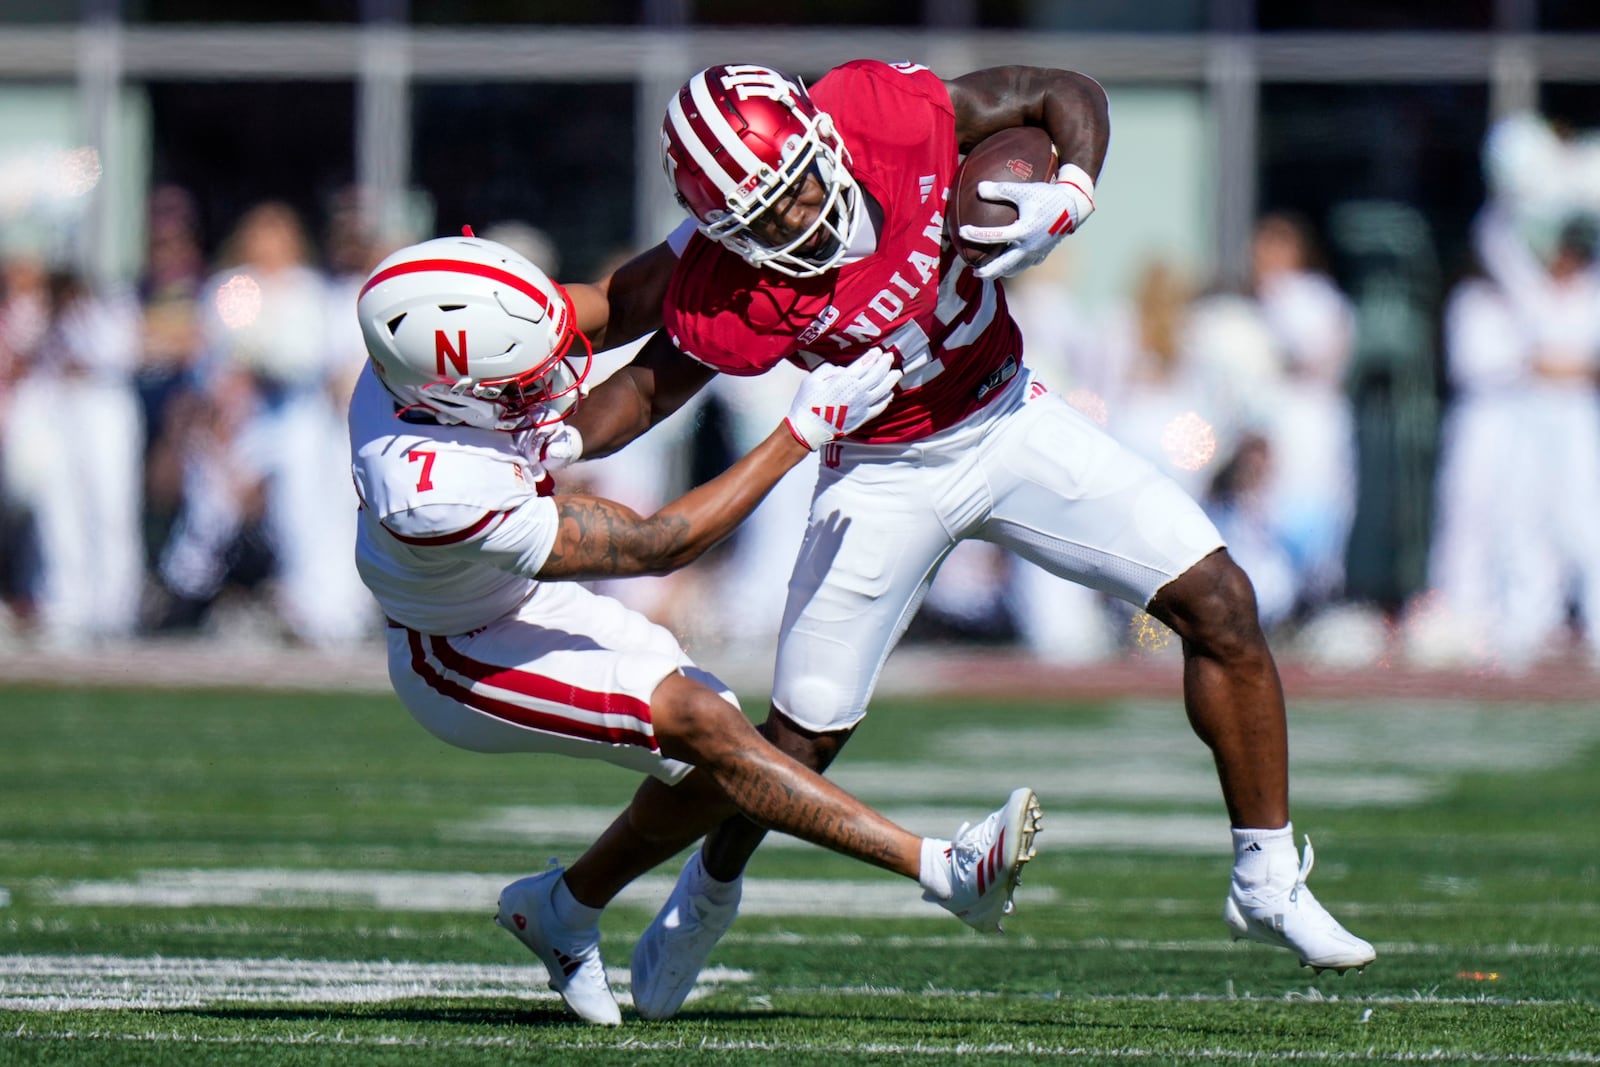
[922,789,1045,934]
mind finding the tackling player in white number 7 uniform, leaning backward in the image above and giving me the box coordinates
[350,232,1040,1024]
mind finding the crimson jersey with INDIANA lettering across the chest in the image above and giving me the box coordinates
[662,59,1022,443]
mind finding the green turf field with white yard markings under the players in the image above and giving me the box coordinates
[0,688,1600,1067]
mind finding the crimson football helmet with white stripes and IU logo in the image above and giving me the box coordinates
[661,66,861,278]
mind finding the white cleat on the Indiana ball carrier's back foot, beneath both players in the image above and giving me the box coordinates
[634,857,744,1019]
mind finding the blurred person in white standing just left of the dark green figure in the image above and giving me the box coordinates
[1251,213,1357,611]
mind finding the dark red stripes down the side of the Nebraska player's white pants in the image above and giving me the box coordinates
[406,629,658,752]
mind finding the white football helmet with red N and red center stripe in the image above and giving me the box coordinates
[355,234,594,432]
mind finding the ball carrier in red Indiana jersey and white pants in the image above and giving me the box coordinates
[550,61,1374,1017]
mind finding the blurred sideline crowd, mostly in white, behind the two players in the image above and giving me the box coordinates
[0,3,1600,673]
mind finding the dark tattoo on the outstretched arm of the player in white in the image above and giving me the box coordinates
[539,496,693,579]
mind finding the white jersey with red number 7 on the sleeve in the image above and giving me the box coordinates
[350,365,558,635]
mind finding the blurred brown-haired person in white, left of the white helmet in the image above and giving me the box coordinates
[162,202,370,645]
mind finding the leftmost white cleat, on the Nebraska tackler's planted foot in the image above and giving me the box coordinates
[494,867,622,1027]
